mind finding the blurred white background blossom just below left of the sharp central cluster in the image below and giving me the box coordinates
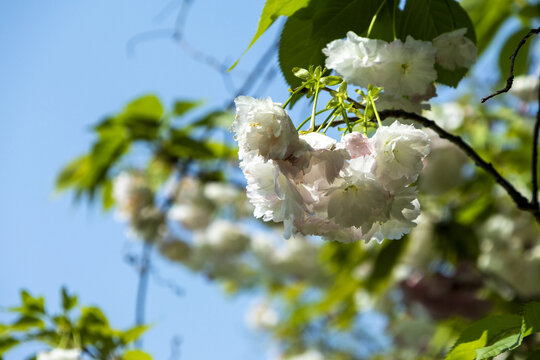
[195,220,249,255]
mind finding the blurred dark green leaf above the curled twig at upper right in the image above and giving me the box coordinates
[499,29,531,81]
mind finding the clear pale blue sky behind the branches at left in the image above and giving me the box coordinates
[0,0,292,360]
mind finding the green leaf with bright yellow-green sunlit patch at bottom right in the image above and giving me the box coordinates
[446,315,525,360]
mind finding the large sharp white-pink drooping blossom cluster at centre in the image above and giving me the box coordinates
[232,96,429,242]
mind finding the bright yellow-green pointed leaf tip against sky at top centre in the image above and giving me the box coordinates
[227,0,310,71]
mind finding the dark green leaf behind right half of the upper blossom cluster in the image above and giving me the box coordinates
[398,0,476,87]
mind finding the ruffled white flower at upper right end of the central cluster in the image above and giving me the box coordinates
[371,121,429,185]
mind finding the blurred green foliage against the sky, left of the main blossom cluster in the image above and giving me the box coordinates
[56,95,236,210]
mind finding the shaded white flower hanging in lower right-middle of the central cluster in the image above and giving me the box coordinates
[327,157,390,232]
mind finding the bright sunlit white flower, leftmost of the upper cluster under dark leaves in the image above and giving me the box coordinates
[323,31,386,87]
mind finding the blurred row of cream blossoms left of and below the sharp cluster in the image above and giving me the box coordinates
[113,171,325,287]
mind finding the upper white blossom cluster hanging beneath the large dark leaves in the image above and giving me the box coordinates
[323,28,477,112]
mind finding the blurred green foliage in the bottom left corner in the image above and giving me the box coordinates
[0,288,151,360]
